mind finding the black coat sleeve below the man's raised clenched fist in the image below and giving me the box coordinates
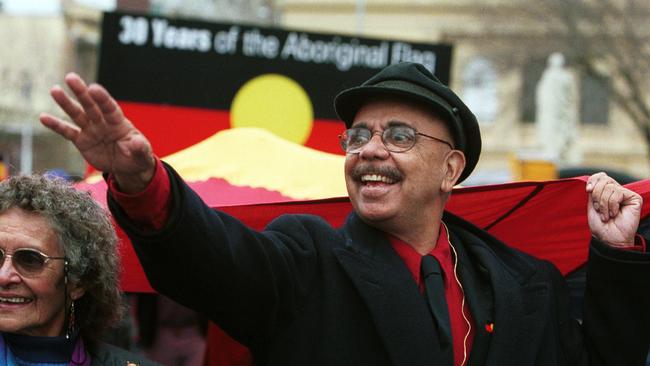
[583,239,650,366]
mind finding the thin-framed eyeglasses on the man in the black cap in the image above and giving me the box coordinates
[339,126,454,154]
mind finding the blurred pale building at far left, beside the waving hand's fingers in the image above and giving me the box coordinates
[0,6,83,173]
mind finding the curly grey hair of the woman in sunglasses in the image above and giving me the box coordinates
[0,175,124,347]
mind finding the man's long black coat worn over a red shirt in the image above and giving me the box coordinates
[109,168,650,366]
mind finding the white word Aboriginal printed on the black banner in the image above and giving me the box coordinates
[281,32,388,71]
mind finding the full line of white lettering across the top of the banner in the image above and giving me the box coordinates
[115,16,436,73]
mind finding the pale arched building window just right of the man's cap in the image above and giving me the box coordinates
[462,57,499,123]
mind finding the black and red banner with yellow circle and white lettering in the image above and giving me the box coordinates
[98,13,451,158]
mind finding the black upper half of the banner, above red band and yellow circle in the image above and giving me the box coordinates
[98,13,451,119]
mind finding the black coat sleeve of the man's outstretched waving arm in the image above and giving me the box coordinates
[108,162,317,346]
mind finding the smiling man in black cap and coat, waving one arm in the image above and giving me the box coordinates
[41,63,650,366]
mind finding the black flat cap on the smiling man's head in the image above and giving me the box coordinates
[334,62,481,183]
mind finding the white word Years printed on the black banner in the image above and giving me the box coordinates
[151,19,212,52]
